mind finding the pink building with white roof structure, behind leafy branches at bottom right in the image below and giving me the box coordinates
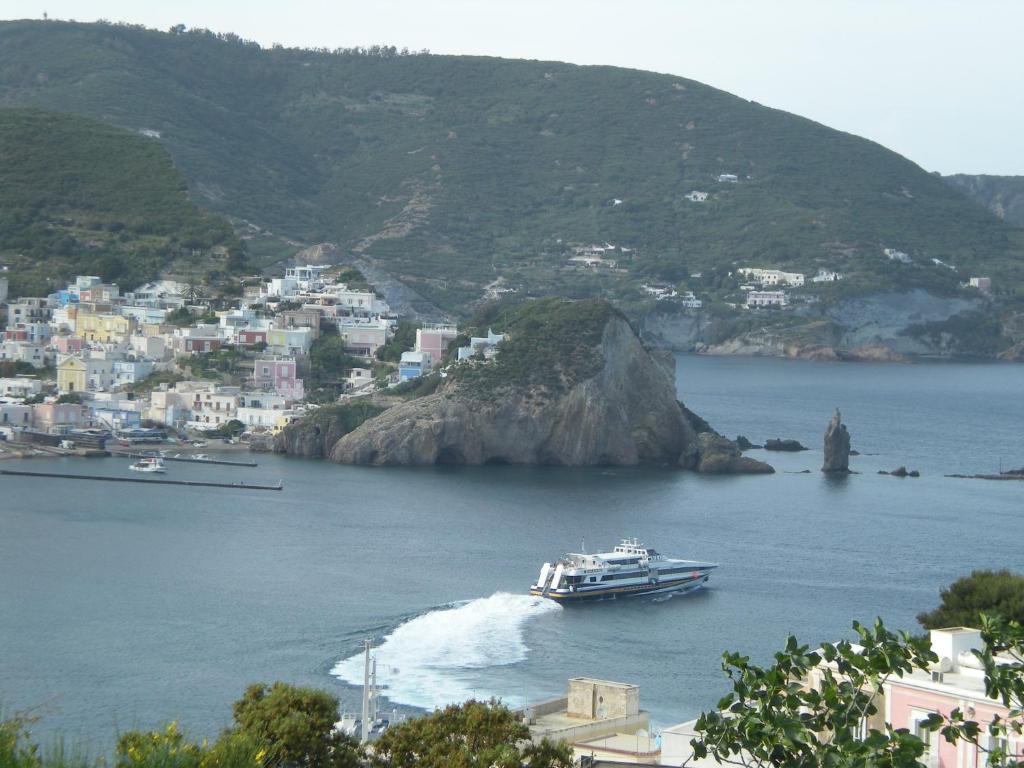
[886,627,1024,768]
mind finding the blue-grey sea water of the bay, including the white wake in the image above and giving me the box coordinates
[0,356,1024,751]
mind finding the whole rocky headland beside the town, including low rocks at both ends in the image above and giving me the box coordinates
[275,299,773,473]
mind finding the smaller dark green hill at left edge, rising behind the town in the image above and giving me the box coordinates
[0,109,241,296]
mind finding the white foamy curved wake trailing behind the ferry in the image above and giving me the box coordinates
[331,592,562,709]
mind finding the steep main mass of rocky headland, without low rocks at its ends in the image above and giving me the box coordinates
[330,307,698,467]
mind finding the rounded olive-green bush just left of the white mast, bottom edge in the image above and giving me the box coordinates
[233,682,359,768]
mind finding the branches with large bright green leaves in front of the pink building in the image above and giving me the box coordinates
[684,615,1024,768]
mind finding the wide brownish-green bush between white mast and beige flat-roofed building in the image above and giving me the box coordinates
[370,700,573,768]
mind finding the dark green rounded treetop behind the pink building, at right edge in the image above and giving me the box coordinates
[918,568,1024,630]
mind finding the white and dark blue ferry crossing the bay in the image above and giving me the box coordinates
[529,539,718,602]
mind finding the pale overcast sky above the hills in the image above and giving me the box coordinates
[0,0,1024,175]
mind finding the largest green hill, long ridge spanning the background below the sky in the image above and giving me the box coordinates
[0,22,1024,309]
